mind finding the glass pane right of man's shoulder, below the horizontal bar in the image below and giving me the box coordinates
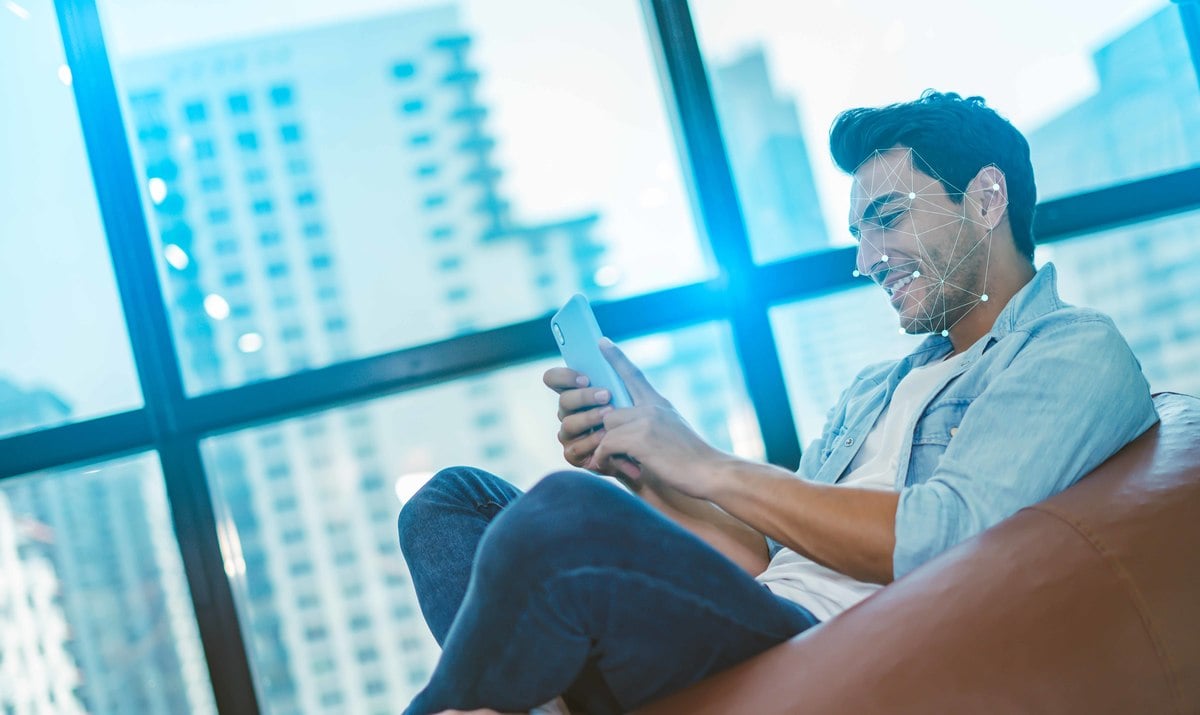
[1038,212,1200,395]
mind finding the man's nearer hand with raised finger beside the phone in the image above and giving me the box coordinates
[587,340,733,499]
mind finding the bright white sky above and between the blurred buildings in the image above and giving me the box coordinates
[0,0,1165,427]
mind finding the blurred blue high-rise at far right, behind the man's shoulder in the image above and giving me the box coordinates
[1030,5,1200,393]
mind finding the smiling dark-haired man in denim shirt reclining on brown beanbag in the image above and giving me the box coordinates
[400,92,1157,714]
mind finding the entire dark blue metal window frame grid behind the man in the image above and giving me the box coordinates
[0,0,1200,713]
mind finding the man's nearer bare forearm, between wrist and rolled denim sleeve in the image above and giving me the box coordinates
[709,462,899,584]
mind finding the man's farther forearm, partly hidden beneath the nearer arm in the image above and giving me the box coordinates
[637,480,770,576]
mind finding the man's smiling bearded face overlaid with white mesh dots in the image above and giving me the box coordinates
[850,148,990,334]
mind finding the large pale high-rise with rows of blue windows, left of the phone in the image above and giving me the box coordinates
[121,7,624,714]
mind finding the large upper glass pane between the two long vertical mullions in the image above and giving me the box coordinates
[102,0,712,393]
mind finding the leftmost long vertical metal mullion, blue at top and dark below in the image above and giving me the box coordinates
[55,0,258,715]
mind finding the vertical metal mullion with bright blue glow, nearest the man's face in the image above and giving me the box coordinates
[646,0,800,468]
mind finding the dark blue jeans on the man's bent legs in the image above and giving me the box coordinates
[400,467,817,715]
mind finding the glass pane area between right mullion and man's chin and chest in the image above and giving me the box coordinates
[770,284,925,447]
